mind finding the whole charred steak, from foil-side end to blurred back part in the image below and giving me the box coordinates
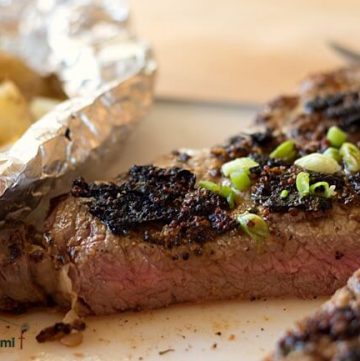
[0,68,360,315]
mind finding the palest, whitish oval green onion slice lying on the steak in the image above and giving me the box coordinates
[295,153,338,174]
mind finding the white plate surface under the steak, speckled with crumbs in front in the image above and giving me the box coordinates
[0,103,322,361]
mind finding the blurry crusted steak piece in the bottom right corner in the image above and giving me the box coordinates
[266,271,360,361]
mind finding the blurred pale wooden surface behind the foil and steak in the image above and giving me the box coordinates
[130,0,360,102]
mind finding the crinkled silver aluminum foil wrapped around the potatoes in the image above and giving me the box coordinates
[0,0,155,223]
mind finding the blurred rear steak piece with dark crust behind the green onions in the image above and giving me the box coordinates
[257,67,360,145]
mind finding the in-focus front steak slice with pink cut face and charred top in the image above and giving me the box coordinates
[46,133,360,314]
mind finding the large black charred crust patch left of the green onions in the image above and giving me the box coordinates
[72,165,236,248]
